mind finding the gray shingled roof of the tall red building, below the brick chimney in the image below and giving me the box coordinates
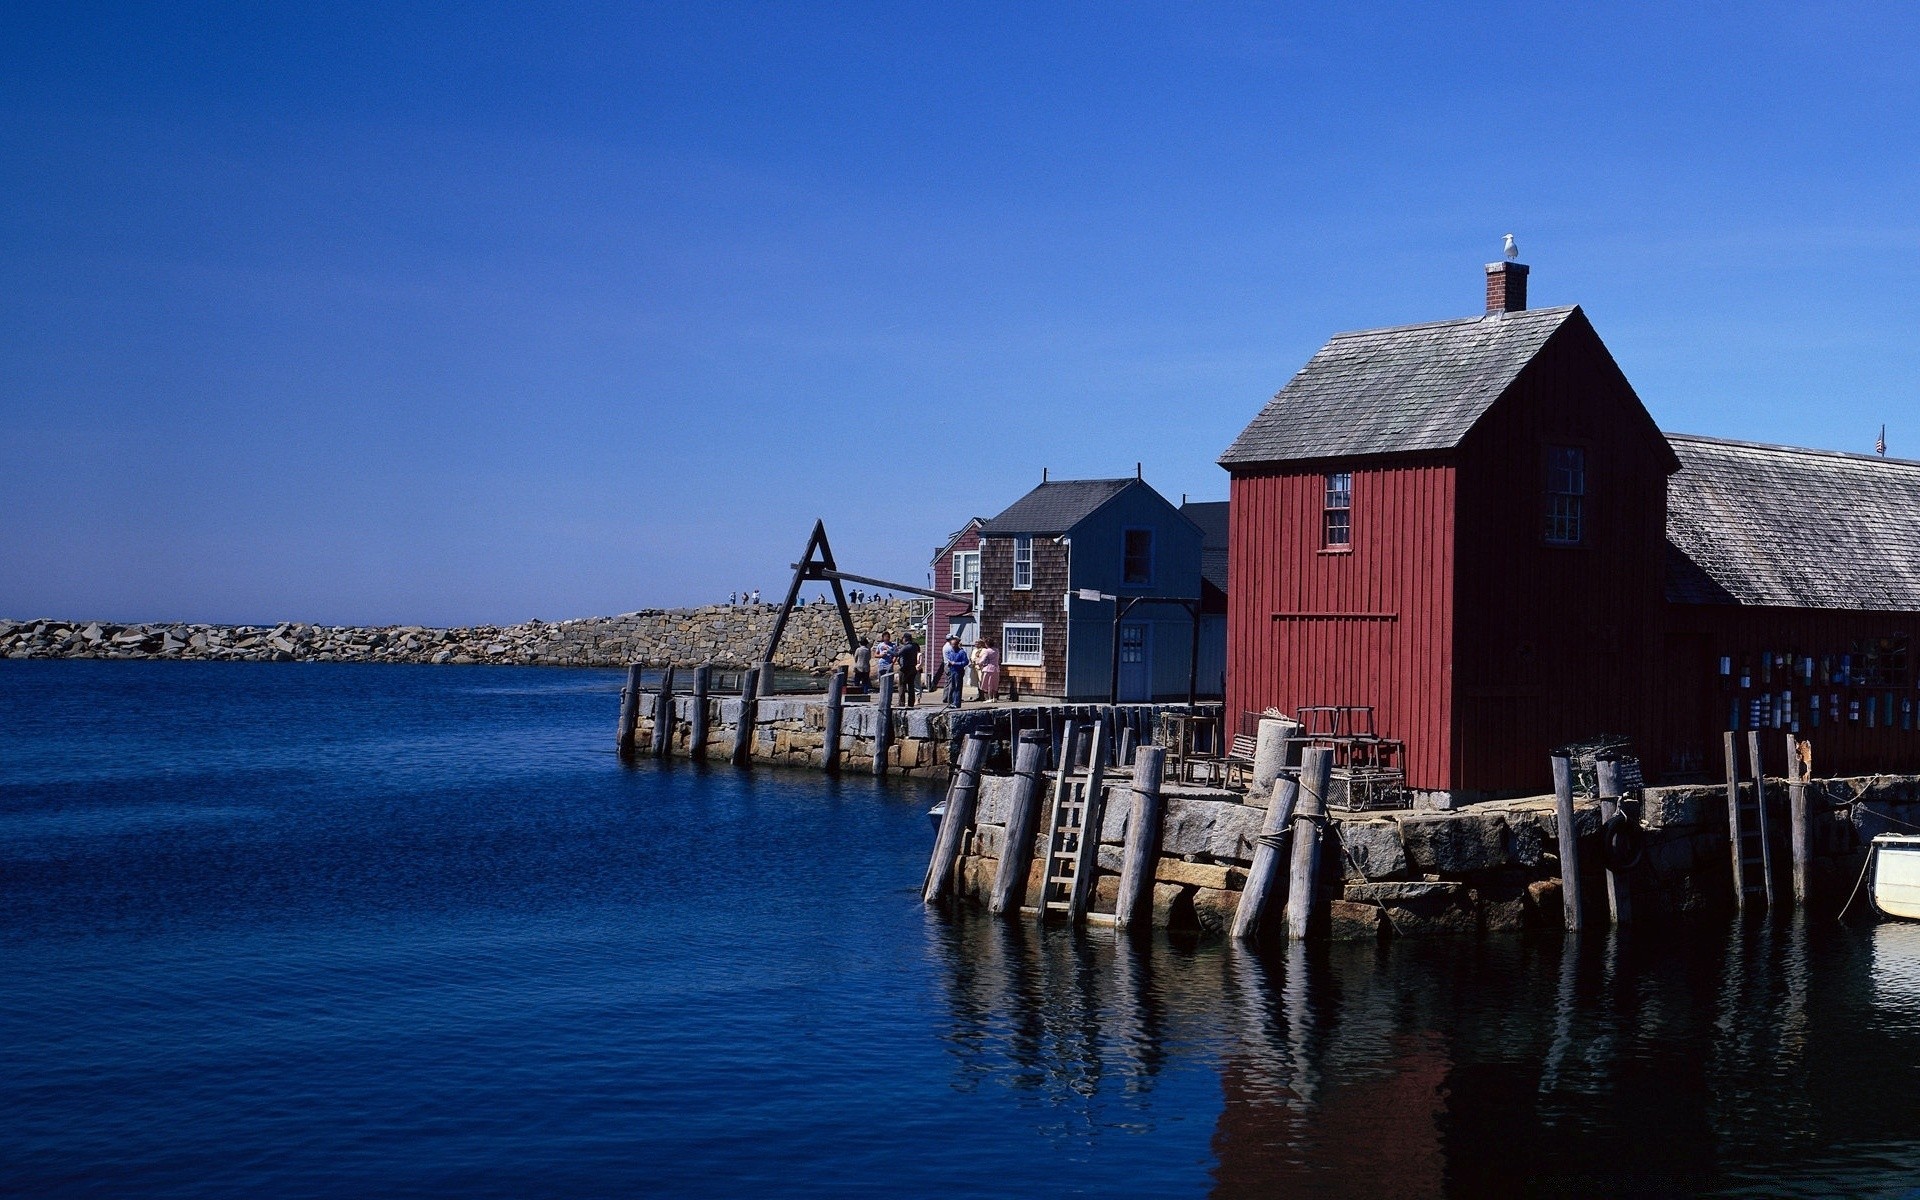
[1219,305,1586,468]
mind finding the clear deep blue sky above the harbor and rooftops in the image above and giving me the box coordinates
[0,2,1920,624]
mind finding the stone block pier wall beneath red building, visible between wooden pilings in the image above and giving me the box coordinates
[933,776,1920,939]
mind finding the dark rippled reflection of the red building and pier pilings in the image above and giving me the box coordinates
[929,916,1920,1196]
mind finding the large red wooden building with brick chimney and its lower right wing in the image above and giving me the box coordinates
[1219,255,1920,801]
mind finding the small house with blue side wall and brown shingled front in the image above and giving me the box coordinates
[979,476,1206,701]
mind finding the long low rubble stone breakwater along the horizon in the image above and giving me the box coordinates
[0,601,918,672]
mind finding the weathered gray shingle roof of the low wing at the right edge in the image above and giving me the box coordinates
[1667,434,1920,612]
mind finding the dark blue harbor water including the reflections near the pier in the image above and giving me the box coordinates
[0,662,1920,1198]
